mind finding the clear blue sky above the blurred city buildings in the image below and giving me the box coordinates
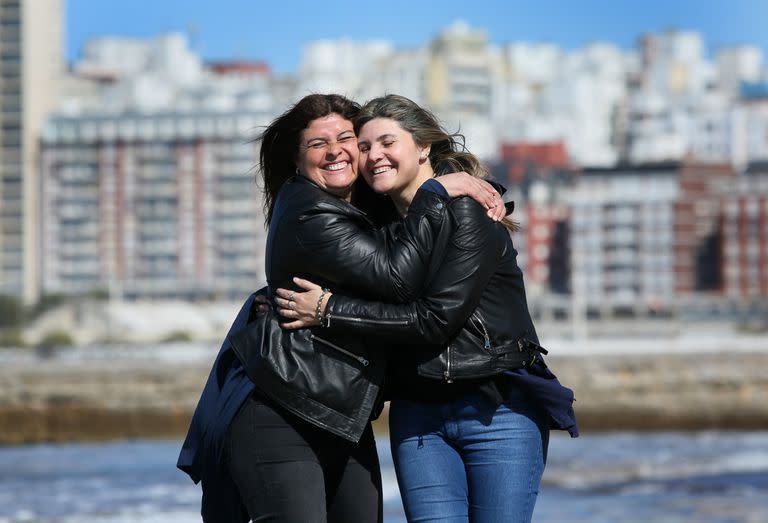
[65,0,768,72]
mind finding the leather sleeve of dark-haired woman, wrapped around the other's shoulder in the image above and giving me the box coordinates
[296,186,451,302]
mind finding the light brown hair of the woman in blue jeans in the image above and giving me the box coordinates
[354,94,518,231]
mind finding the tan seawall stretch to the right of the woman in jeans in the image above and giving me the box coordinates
[550,352,768,430]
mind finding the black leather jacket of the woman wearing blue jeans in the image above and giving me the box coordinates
[326,198,546,387]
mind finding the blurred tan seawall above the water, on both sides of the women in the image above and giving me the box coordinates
[0,347,768,444]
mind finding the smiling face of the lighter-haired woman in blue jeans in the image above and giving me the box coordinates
[357,118,429,196]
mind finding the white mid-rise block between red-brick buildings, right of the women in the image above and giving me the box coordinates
[566,166,678,314]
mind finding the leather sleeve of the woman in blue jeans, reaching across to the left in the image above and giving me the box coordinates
[326,198,507,344]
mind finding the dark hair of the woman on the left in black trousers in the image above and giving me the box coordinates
[255,94,360,225]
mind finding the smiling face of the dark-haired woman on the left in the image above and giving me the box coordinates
[296,113,359,199]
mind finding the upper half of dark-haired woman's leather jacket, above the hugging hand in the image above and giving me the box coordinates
[267,182,450,301]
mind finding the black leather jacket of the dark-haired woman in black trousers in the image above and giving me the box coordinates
[230,177,450,441]
